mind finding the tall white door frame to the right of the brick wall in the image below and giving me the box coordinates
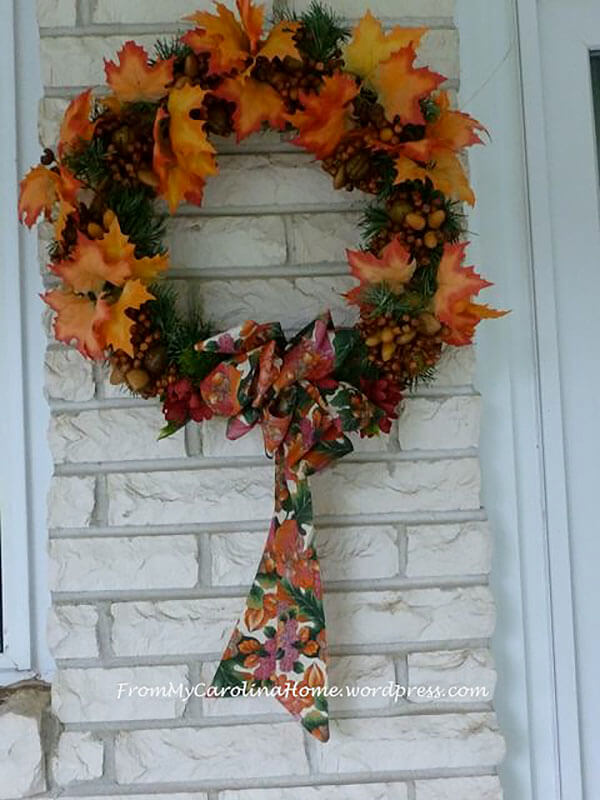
[457,0,583,800]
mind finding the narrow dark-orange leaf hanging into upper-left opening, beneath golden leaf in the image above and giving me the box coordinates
[152,108,204,214]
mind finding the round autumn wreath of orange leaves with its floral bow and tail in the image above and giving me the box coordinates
[19,0,505,741]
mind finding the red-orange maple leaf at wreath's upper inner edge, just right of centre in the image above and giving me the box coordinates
[288,72,358,159]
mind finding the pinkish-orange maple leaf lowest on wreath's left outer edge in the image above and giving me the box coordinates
[42,288,110,360]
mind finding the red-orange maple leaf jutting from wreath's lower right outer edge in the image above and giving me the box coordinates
[433,242,508,346]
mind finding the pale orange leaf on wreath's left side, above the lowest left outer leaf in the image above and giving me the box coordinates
[51,231,131,296]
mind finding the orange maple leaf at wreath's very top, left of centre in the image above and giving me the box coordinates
[182,3,250,75]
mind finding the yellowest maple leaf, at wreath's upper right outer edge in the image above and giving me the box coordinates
[343,11,427,81]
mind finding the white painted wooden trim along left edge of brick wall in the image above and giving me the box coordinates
[0,0,53,683]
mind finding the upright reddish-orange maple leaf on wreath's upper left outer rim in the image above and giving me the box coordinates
[104,41,175,103]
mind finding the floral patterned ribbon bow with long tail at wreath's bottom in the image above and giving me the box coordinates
[197,314,382,741]
